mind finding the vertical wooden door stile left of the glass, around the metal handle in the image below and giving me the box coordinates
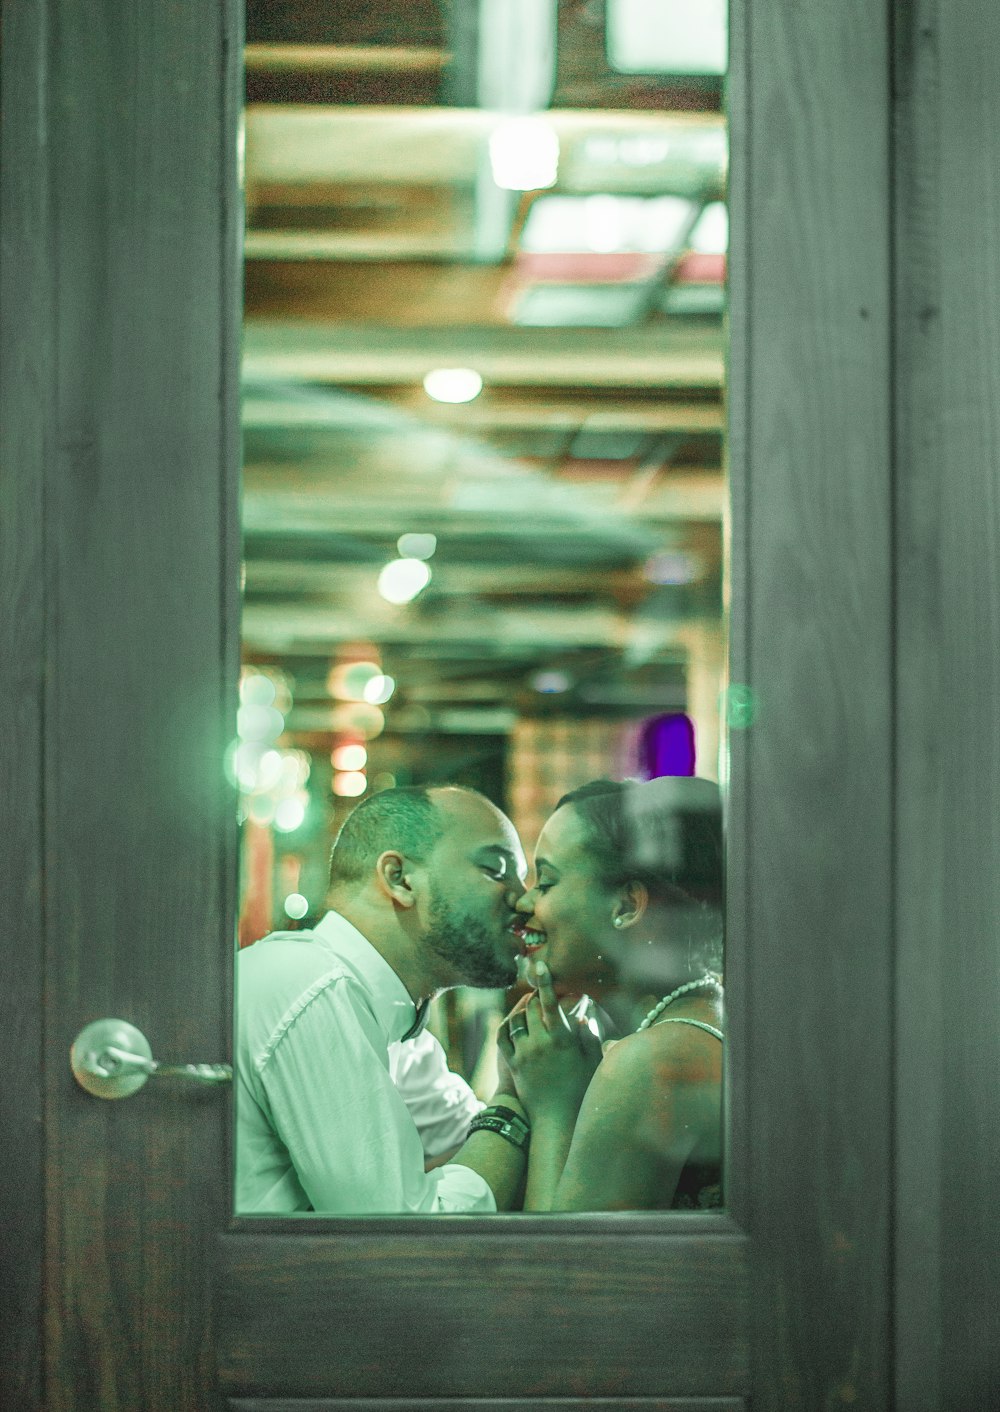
[37,0,239,1412]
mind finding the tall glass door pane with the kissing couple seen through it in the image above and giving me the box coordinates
[238,0,727,1214]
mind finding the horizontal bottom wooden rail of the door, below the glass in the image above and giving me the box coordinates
[218,1216,749,1398]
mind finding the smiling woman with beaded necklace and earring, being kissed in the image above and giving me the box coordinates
[504,778,723,1210]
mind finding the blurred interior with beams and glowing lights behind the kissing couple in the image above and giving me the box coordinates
[238,0,727,1083]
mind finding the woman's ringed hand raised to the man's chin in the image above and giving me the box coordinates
[499,962,600,1121]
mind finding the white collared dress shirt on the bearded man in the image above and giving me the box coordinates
[236,912,496,1216]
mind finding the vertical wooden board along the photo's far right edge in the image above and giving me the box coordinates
[895,0,1000,1412]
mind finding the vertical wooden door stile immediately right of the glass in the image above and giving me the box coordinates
[727,0,893,1412]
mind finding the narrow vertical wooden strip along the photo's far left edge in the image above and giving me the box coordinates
[0,4,52,1412]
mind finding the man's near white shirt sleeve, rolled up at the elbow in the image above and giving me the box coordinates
[257,979,496,1214]
